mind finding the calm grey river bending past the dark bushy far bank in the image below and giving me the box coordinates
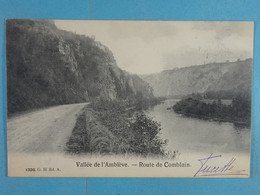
[147,100,250,154]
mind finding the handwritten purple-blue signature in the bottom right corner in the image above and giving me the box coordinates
[194,154,248,177]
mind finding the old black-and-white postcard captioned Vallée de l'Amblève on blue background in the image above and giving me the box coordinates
[6,19,254,178]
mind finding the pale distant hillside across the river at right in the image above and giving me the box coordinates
[142,59,252,96]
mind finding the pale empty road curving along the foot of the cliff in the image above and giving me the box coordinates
[7,103,87,153]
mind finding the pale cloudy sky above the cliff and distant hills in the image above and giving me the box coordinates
[54,20,254,74]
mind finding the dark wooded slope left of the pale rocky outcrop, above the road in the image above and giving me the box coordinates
[6,20,85,115]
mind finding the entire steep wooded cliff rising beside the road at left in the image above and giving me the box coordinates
[6,20,153,113]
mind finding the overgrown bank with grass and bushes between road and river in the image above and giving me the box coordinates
[67,101,169,156]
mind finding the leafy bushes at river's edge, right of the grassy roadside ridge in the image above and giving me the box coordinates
[91,99,166,156]
